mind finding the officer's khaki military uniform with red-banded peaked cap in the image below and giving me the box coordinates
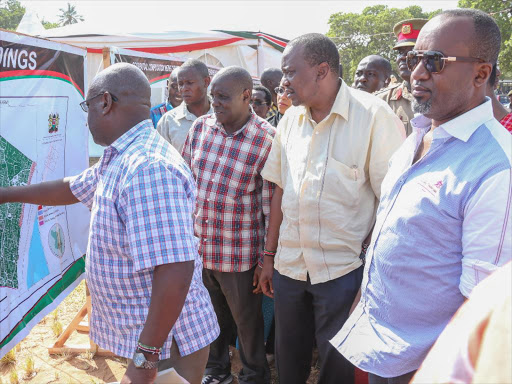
[374,19,428,136]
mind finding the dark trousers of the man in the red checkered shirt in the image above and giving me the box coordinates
[203,268,270,384]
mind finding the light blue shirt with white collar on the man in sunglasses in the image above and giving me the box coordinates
[331,99,512,377]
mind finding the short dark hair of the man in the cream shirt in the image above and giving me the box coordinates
[288,33,340,75]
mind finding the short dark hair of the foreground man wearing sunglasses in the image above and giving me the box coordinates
[439,8,501,65]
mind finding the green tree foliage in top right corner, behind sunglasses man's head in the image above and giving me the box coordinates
[458,0,512,79]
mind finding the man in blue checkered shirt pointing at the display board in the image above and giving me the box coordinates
[0,63,219,384]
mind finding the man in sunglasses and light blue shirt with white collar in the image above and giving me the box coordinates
[332,9,512,384]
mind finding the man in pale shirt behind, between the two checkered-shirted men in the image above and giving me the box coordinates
[157,59,213,153]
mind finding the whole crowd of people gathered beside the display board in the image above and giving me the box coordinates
[0,9,512,384]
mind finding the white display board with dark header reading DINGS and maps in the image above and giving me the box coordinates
[0,30,90,356]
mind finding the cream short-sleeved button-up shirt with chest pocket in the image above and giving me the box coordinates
[261,82,403,284]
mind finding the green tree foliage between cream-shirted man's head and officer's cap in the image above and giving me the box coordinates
[327,5,442,84]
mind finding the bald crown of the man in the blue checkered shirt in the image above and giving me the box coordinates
[89,63,151,107]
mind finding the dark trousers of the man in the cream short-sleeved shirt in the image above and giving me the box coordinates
[273,267,363,384]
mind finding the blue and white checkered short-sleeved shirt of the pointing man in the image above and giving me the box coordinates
[70,120,219,359]
